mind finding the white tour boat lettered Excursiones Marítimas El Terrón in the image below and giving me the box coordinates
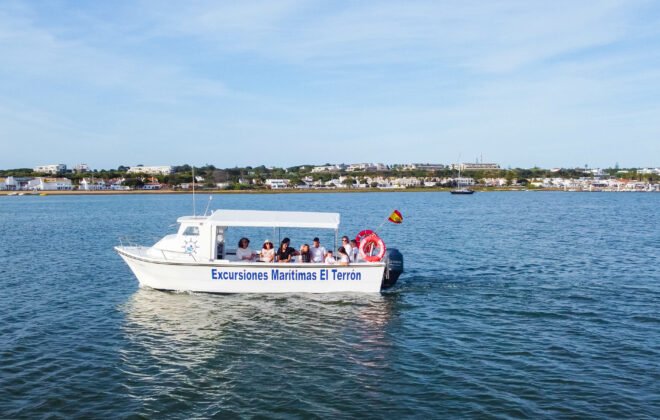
[115,210,403,293]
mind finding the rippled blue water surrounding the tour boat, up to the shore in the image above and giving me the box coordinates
[0,192,660,418]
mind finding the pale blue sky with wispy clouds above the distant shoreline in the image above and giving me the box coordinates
[0,0,660,168]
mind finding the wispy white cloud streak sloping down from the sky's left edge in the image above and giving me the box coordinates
[0,4,228,102]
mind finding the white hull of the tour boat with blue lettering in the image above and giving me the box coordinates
[115,247,385,293]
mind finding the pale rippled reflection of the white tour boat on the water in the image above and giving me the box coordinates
[120,289,396,414]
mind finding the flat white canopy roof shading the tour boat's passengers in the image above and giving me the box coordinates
[207,210,339,229]
